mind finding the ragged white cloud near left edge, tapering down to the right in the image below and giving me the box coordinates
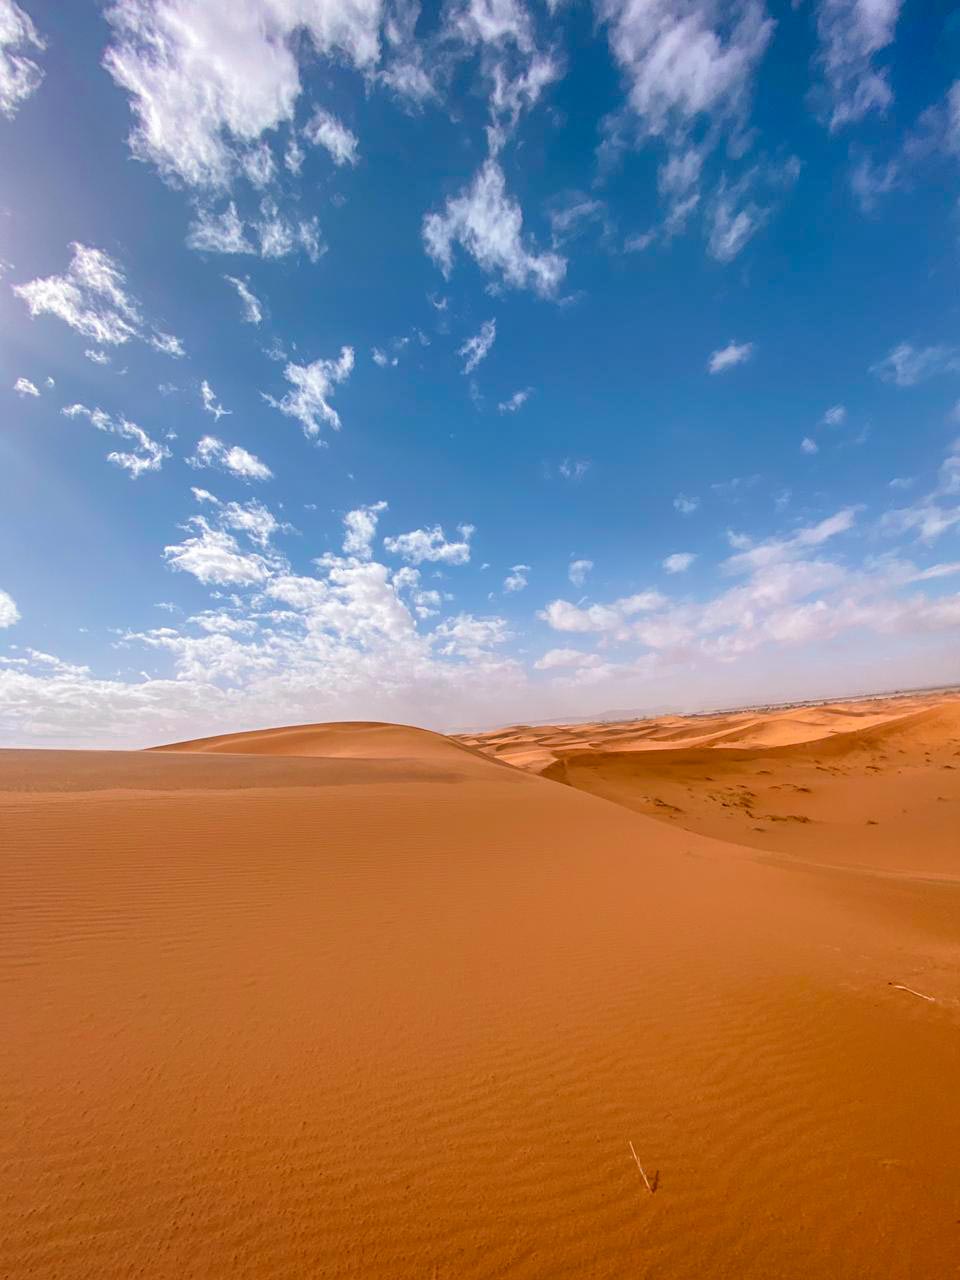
[13,243,183,356]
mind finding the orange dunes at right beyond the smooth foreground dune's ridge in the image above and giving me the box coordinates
[467,695,960,879]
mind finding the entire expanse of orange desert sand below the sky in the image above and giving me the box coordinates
[0,696,960,1280]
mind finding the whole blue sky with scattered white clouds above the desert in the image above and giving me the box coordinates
[0,0,960,746]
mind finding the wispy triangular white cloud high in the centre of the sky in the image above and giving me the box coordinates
[424,159,567,297]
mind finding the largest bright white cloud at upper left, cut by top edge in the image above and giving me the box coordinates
[104,0,381,189]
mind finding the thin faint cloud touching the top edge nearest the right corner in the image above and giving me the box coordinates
[817,0,902,131]
